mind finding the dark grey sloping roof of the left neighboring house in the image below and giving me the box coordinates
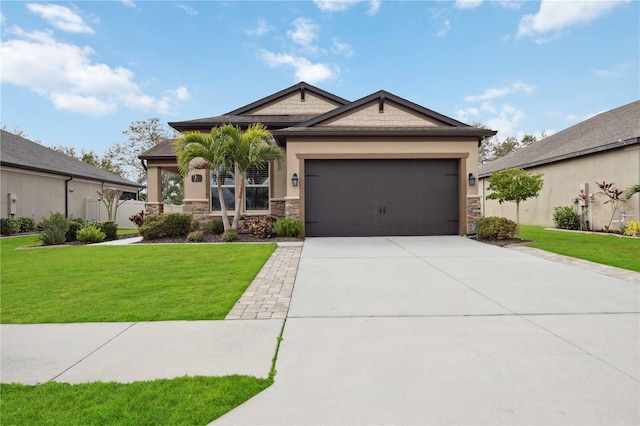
[0,130,142,188]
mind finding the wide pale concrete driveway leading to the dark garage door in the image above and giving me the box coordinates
[215,237,640,425]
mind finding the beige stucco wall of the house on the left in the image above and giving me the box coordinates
[0,167,137,222]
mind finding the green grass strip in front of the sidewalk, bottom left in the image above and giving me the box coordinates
[0,376,273,426]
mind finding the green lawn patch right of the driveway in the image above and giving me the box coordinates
[520,225,640,272]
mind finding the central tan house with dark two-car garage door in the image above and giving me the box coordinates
[140,83,496,236]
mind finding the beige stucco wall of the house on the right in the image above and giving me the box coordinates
[479,145,640,230]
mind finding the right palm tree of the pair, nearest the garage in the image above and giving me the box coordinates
[218,123,284,230]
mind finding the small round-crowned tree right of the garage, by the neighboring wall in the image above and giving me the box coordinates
[487,168,544,238]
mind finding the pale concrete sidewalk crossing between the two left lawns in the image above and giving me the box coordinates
[0,320,284,385]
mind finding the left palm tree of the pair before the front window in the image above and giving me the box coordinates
[173,127,234,231]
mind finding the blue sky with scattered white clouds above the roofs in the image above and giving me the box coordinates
[0,0,640,153]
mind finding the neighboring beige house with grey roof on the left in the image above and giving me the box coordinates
[0,130,141,222]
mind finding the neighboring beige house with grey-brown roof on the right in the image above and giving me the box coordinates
[479,101,640,230]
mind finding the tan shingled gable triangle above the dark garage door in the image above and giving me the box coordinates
[320,100,442,127]
